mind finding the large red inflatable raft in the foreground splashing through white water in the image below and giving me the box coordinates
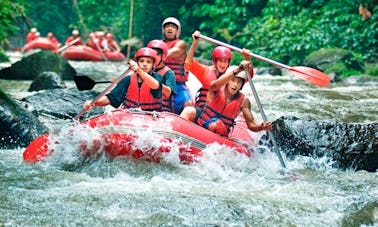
[23,110,253,163]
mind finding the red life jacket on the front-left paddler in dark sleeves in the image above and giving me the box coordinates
[125,73,161,112]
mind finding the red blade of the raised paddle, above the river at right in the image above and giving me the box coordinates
[289,66,331,87]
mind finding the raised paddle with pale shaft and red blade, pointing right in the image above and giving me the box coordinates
[200,35,331,87]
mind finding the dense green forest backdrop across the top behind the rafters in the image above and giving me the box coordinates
[0,0,378,75]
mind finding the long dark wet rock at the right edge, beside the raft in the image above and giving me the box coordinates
[273,117,378,171]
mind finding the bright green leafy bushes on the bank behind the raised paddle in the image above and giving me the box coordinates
[183,0,378,65]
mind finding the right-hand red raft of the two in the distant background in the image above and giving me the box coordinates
[61,45,125,61]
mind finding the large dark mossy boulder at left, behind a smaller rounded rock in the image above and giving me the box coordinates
[0,50,76,80]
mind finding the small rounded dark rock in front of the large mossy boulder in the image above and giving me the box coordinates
[28,72,66,91]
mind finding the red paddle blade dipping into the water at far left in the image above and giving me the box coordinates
[23,133,50,163]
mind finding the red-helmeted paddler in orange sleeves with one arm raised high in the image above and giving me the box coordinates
[185,31,253,109]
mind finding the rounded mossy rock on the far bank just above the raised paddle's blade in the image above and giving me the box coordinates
[304,48,364,77]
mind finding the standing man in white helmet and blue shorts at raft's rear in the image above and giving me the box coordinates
[162,17,193,114]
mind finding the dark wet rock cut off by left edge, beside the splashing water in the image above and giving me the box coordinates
[0,90,47,149]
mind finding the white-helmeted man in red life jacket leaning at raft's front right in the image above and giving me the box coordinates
[180,60,272,136]
